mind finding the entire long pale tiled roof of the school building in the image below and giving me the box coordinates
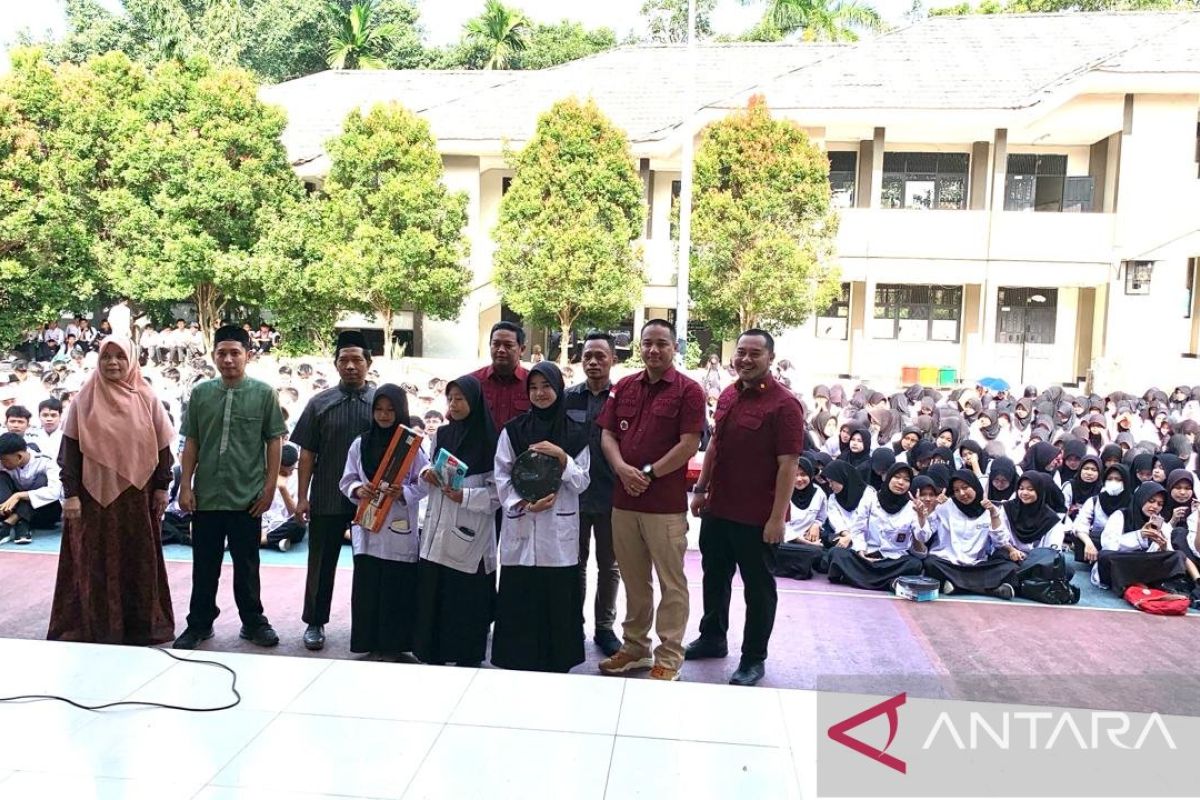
[260,12,1200,164]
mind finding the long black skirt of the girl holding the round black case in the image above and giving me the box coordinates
[492,566,583,672]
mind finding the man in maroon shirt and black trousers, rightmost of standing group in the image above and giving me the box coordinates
[685,327,804,686]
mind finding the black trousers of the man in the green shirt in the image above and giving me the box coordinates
[187,511,266,631]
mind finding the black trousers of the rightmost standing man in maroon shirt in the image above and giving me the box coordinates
[700,516,778,661]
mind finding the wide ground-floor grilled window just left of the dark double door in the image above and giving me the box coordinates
[871,283,962,342]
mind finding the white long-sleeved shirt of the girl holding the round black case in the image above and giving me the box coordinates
[496,431,592,566]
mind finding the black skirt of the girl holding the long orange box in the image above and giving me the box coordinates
[350,555,416,654]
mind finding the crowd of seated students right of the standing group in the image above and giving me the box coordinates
[778,386,1200,604]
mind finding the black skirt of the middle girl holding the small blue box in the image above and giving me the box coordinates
[413,559,494,664]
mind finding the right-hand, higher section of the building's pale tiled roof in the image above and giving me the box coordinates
[719,12,1200,110]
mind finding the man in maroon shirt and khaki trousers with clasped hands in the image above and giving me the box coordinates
[596,319,704,680]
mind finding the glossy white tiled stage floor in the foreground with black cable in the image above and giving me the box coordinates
[0,639,815,800]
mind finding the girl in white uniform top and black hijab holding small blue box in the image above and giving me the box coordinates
[413,375,499,667]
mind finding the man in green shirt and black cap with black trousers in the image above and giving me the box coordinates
[174,325,287,650]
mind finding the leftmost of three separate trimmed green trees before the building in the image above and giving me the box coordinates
[319,103,472,351]
